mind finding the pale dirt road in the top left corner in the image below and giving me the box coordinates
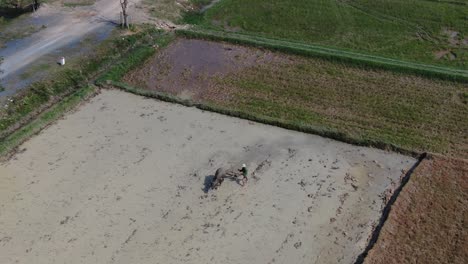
[0,0,139,78]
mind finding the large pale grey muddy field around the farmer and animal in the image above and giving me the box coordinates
[0,90,415,264]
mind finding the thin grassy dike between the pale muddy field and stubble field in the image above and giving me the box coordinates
[101,80,420,157]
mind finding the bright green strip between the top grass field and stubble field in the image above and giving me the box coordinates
[176,28,468,83]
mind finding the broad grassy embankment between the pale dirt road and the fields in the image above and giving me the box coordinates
[0,29,168,155]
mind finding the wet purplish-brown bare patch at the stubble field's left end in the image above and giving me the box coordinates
[123,39,288,100]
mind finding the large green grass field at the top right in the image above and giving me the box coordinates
[196,0,468,69]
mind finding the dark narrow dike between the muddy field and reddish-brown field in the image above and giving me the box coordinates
[355,153,430,264]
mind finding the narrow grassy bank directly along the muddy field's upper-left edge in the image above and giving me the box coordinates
[0,86,96,156]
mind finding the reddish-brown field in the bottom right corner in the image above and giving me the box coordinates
[365,157,468,264]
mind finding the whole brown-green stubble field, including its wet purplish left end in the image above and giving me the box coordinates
[123,39,468,156]
